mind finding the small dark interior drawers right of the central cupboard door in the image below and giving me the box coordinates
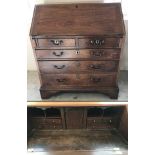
[87,117,117,129]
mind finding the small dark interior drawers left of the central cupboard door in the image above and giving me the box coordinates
[32,117,63,129]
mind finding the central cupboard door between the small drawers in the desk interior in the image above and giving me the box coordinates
[65,108,85,129]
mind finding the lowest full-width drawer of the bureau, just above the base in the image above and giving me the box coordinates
[41,73,117,89]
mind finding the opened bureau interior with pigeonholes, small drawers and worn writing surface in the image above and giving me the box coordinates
[27,106,128,151]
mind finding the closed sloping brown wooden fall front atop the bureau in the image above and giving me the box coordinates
[30,3,125,36]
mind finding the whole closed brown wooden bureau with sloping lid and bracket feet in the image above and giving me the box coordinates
[30,3,125,99]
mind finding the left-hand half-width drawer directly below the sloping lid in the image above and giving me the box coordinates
[38,39,75,48]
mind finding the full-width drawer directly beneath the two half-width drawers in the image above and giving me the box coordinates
[36,49,120,60]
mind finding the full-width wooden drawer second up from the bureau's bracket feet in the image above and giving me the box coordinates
[38,61,119,74]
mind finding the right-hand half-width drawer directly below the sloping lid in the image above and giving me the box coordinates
[79,38,120,48]
